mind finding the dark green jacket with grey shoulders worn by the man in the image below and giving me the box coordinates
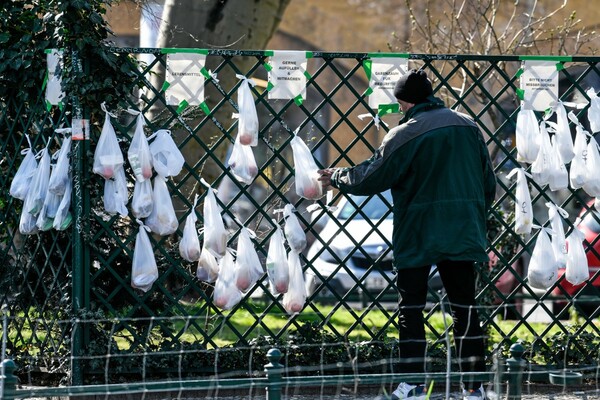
[332,97,496,269]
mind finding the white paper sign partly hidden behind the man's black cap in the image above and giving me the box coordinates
[369,57,408,110]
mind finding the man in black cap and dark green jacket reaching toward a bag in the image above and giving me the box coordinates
[320,70,496,399]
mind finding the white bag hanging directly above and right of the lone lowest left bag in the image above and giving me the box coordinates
[146,175,179,236]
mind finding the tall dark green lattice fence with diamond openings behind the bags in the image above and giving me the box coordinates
[0,48,600,384]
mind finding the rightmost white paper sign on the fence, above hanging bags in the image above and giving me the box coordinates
[520,60,558,111]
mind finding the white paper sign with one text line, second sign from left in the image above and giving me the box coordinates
[165,53,206,106]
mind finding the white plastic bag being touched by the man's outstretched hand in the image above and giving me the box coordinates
[290,130,324,200]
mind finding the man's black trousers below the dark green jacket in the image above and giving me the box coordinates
[397,261,485,389]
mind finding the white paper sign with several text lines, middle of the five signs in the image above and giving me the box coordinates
[269,51,308,100]
